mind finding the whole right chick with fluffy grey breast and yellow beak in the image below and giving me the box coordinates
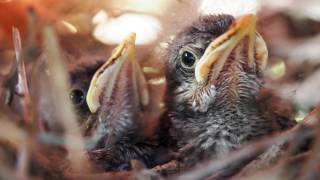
[166,1,295,170]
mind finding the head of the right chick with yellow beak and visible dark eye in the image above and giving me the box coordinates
[167,14,268,112]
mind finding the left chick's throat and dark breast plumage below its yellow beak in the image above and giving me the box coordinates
[81,48,165,171]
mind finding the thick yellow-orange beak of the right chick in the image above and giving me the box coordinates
[195,14,268,83]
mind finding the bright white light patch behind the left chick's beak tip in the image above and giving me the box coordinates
[93,13,161,45]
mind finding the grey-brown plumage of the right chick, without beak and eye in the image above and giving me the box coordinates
[166,15,295,166]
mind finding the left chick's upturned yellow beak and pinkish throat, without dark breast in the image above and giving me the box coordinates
[86,33,149,139]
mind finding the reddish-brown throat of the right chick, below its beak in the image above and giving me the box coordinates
[215,46,263,105]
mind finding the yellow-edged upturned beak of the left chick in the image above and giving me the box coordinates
[87,33,149,113]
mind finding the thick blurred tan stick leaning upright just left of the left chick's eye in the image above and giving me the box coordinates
[43,26,90,173]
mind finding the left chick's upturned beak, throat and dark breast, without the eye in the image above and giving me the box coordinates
[86,33,164,171]
